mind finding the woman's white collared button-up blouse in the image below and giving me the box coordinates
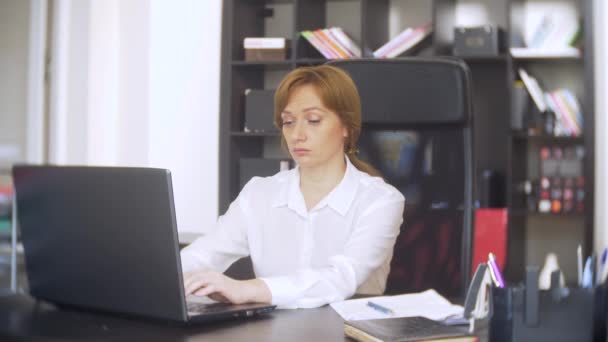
[181,158,405,308]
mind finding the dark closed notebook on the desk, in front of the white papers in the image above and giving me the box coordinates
[344,316,477,342]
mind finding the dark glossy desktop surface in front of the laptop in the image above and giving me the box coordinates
[0,295,346,342]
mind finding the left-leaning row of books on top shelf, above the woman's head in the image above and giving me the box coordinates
[300,27,361,59]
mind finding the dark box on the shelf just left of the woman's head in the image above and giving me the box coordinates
[244,89,278,133]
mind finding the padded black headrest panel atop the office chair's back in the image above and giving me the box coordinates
[328,57,472,126]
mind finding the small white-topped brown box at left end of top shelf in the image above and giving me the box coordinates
[243,37,289,62]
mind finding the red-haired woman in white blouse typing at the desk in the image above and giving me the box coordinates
[181,65,404,308]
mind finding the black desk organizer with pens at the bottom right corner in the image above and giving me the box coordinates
[489,272,606,342]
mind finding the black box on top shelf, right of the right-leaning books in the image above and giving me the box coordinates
[454,25,505,56]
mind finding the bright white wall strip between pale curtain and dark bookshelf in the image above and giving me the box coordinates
[149,0,222,231]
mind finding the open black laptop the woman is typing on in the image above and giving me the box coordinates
[13,165,274,322]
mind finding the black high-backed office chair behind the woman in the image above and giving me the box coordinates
[330,57,475,298]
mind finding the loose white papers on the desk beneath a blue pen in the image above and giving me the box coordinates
[331,289,464,321]
